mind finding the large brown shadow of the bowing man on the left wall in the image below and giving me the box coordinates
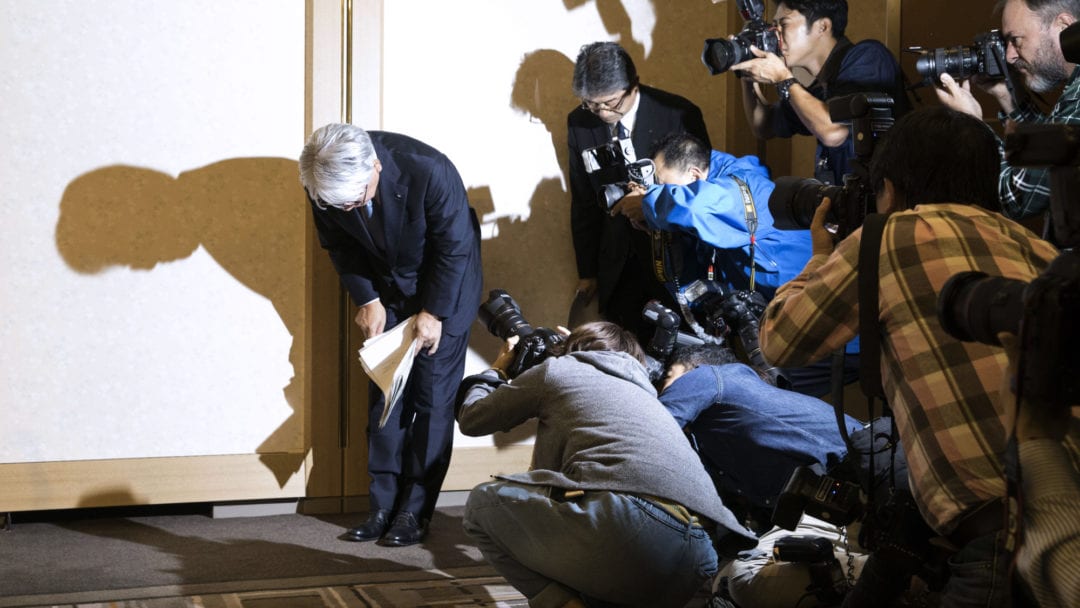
[56,158,308,486]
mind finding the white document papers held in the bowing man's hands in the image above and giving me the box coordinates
[360,314,417,429]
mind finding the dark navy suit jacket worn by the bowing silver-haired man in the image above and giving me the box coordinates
[309,131,483,335]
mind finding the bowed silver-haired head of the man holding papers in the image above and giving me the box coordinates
[300,123,376,208]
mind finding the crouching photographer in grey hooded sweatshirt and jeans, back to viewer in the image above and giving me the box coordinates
[457,322,755,608]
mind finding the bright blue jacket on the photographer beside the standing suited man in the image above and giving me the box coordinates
[644,150,811,298]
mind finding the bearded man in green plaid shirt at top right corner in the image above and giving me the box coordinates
[936,0,1080,228]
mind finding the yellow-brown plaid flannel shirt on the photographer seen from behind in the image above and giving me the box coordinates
[760,204,1057,533]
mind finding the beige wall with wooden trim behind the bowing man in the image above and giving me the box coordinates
[0,0,911,511]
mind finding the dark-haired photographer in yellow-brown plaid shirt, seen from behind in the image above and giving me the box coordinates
[760,106,1057,606]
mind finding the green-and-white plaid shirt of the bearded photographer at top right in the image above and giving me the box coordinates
[998,67,1080,219]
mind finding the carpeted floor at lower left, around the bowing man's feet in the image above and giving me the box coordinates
[0,506,513,608]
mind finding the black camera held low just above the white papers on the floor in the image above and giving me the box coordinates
[772,462,865,530]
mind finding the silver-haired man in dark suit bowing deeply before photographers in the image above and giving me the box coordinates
[300,124,483,546]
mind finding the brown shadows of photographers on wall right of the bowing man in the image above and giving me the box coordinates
[470,0,727,357]
